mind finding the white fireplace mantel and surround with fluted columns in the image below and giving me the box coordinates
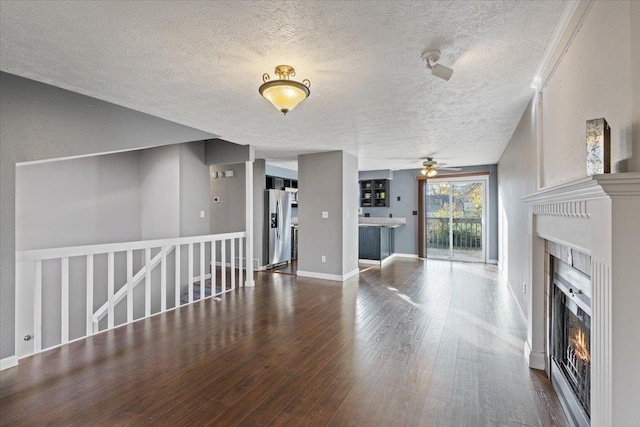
[522,172,640,427]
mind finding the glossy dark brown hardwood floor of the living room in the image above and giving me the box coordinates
[0,258,567,426]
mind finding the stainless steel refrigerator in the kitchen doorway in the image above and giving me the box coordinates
[265,190,291,265]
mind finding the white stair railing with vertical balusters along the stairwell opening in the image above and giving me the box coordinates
[16,232,248,357]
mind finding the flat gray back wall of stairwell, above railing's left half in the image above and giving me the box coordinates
[16,152,141,251]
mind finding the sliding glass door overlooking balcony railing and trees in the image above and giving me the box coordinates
[425,179,486,262]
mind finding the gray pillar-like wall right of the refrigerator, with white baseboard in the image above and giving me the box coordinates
[298,151,358,276]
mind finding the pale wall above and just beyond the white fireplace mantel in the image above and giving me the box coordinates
[498,1,640,316]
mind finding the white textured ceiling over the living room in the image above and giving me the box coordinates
[0,0,565,169]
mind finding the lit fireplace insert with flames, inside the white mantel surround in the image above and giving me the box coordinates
[549,256,592,427]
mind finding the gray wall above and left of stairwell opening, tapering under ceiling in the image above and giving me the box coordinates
[0,73,215,358]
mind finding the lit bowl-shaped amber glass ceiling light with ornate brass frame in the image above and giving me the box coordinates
[258,65,311,115]
